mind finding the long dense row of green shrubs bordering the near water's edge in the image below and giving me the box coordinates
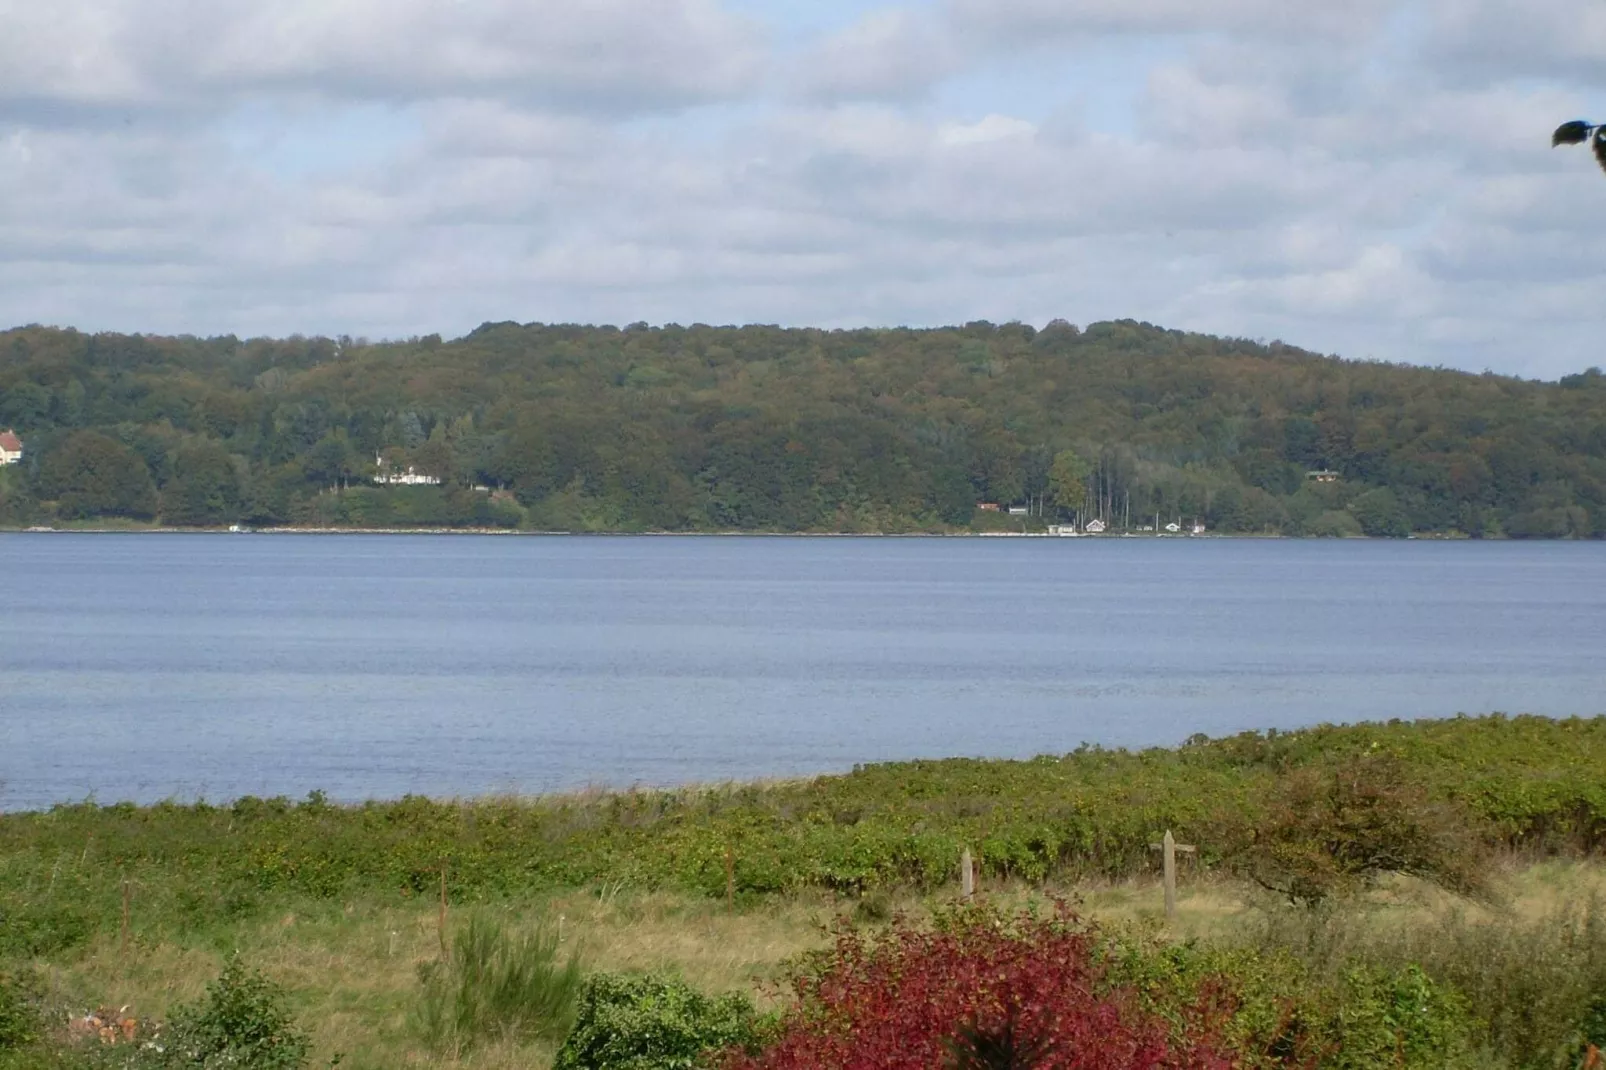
[0,717,1606,956]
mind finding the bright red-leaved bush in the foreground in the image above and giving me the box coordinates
[726,911,1232,1070]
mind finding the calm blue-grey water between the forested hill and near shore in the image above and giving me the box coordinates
[0,535,1606,810]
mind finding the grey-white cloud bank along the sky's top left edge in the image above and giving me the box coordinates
[0,0,763,111]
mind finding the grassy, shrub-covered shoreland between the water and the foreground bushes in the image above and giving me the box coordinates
[9,717,1606,1070]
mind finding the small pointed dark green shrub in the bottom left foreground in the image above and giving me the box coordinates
[144,956,312,1070]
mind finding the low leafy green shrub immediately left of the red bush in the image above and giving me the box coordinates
[552,974,760,1070]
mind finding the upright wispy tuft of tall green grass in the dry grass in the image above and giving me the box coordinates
[418,913,581,1056]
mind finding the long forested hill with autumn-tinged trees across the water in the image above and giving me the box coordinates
[0,314,1606,537]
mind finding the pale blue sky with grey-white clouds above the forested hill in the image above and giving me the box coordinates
[0,0,1606,379]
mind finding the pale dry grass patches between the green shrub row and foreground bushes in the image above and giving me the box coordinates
[31,863,1606,1070]
